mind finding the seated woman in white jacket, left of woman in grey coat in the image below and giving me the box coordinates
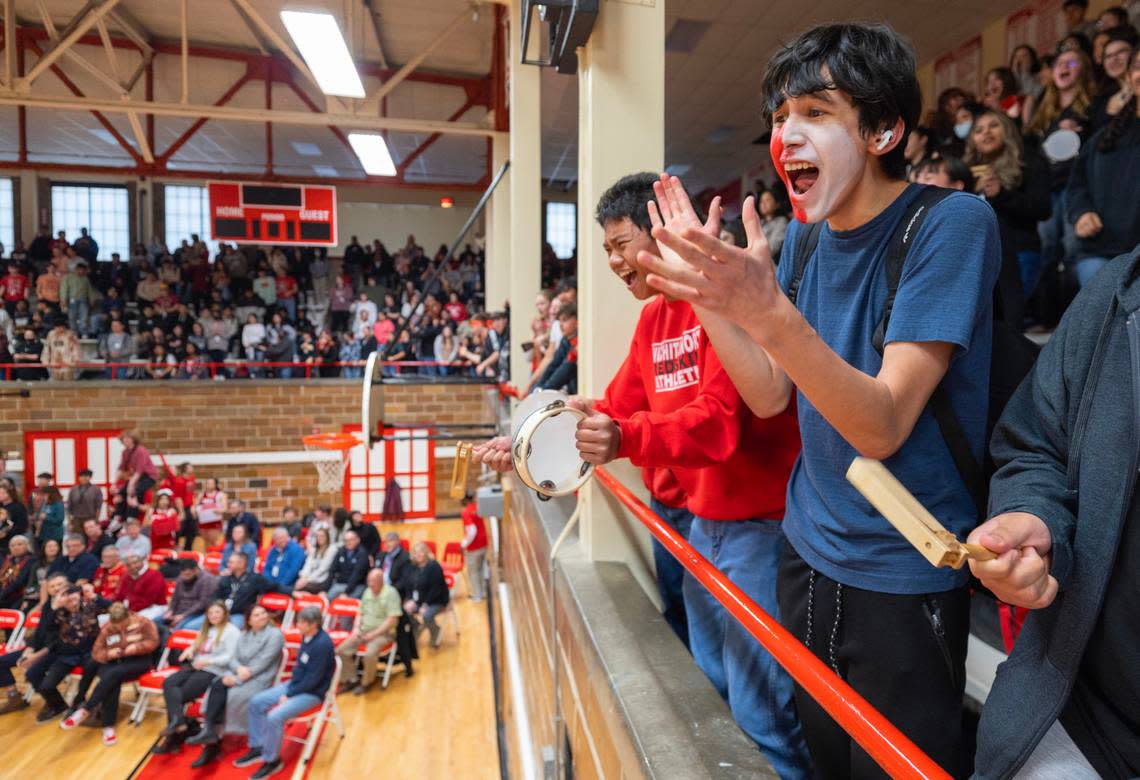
[154,601,242,754]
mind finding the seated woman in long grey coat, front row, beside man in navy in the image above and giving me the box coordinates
[186,604,285,769]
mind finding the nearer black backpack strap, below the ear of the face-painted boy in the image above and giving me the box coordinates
[872,187,986,518]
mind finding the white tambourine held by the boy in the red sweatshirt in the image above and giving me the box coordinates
[511,393,594,498]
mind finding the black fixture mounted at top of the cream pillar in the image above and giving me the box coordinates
[521,0,599,73]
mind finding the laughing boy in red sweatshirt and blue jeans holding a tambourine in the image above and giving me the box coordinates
[481,173,811,780]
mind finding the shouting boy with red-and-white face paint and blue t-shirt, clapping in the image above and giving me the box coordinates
[638,24,1001,778]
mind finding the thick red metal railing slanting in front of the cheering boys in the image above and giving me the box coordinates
[594,466,950,780]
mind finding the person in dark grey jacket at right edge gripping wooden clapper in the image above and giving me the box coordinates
[969,247,1140,780]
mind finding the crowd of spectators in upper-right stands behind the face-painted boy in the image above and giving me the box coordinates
[906,0,1140,326]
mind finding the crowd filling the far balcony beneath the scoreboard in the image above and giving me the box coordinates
[0,227,522,381]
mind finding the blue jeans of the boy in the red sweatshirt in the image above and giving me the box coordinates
[684,517,812,780]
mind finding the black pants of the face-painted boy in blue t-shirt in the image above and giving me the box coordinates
[777,542,970,780]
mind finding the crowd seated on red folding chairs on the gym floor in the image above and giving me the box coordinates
[0,432,487,777]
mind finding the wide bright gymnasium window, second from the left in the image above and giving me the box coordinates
[51,185,131,260]
